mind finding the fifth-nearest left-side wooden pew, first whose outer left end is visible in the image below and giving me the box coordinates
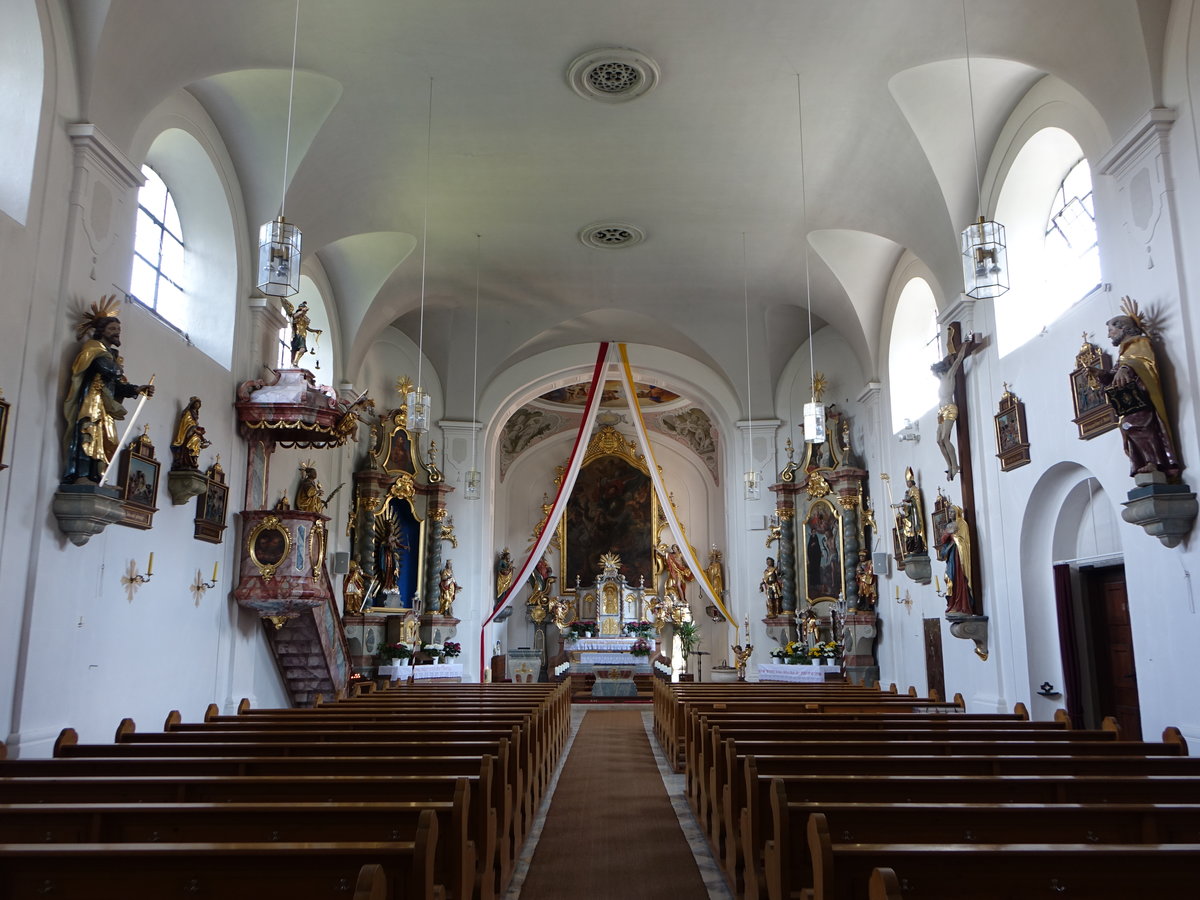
[69,728,535,857]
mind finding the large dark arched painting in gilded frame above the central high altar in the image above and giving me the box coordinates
[559,454,658,590]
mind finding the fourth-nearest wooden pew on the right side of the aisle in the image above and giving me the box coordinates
[739,773,1200,898]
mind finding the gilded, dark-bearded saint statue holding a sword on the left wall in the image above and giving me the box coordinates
[62,294,154,485]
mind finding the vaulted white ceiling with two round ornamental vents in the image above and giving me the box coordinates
[70,0,1169,414]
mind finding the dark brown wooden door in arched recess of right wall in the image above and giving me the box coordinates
[1084,565,1141,740]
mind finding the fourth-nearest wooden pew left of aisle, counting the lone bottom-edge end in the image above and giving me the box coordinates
[0,760,501,899]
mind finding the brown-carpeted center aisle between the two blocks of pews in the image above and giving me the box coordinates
[521,709,709,900]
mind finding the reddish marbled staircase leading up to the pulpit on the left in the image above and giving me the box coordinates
[263,578,350,707]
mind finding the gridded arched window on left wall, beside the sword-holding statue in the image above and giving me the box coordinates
[130,166,186,326]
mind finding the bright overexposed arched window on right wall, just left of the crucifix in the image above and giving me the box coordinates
[888,278,941,432]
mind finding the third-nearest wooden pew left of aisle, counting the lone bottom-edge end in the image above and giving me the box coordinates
[0,792,476,899]
